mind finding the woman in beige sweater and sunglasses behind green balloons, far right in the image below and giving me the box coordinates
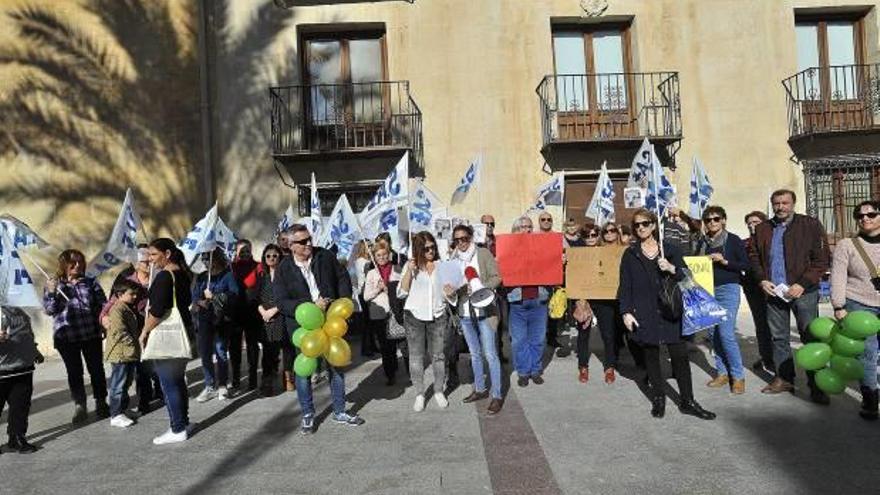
[831,201,880,421]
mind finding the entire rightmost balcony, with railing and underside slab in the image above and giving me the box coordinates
[782,64,880,159]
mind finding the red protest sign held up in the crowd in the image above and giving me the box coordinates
[495,233,562,287]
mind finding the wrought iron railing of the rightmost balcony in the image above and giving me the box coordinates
[782,64,880,138]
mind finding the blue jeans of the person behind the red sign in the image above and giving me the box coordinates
[509,299,547,376]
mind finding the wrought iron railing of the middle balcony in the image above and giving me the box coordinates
[537,72,682,146]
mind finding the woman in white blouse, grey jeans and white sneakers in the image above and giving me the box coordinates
[397,232,449,412]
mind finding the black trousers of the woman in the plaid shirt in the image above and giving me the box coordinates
[55,339,107,405]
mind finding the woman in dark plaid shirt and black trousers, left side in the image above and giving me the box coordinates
[43,249,110,423]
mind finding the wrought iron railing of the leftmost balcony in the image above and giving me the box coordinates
[269,81,422,162]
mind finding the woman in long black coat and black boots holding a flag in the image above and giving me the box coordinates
[617,208,715,419]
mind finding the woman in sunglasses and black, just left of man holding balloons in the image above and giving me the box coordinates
[257,244,294,397]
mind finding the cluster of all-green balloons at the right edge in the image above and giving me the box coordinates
[795,311,880,394]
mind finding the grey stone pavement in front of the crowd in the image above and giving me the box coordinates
[0,304,880,495]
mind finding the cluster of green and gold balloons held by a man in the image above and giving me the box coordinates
[291,297,354,377]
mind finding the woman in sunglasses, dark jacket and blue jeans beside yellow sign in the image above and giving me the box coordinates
[695,205,749,395]
